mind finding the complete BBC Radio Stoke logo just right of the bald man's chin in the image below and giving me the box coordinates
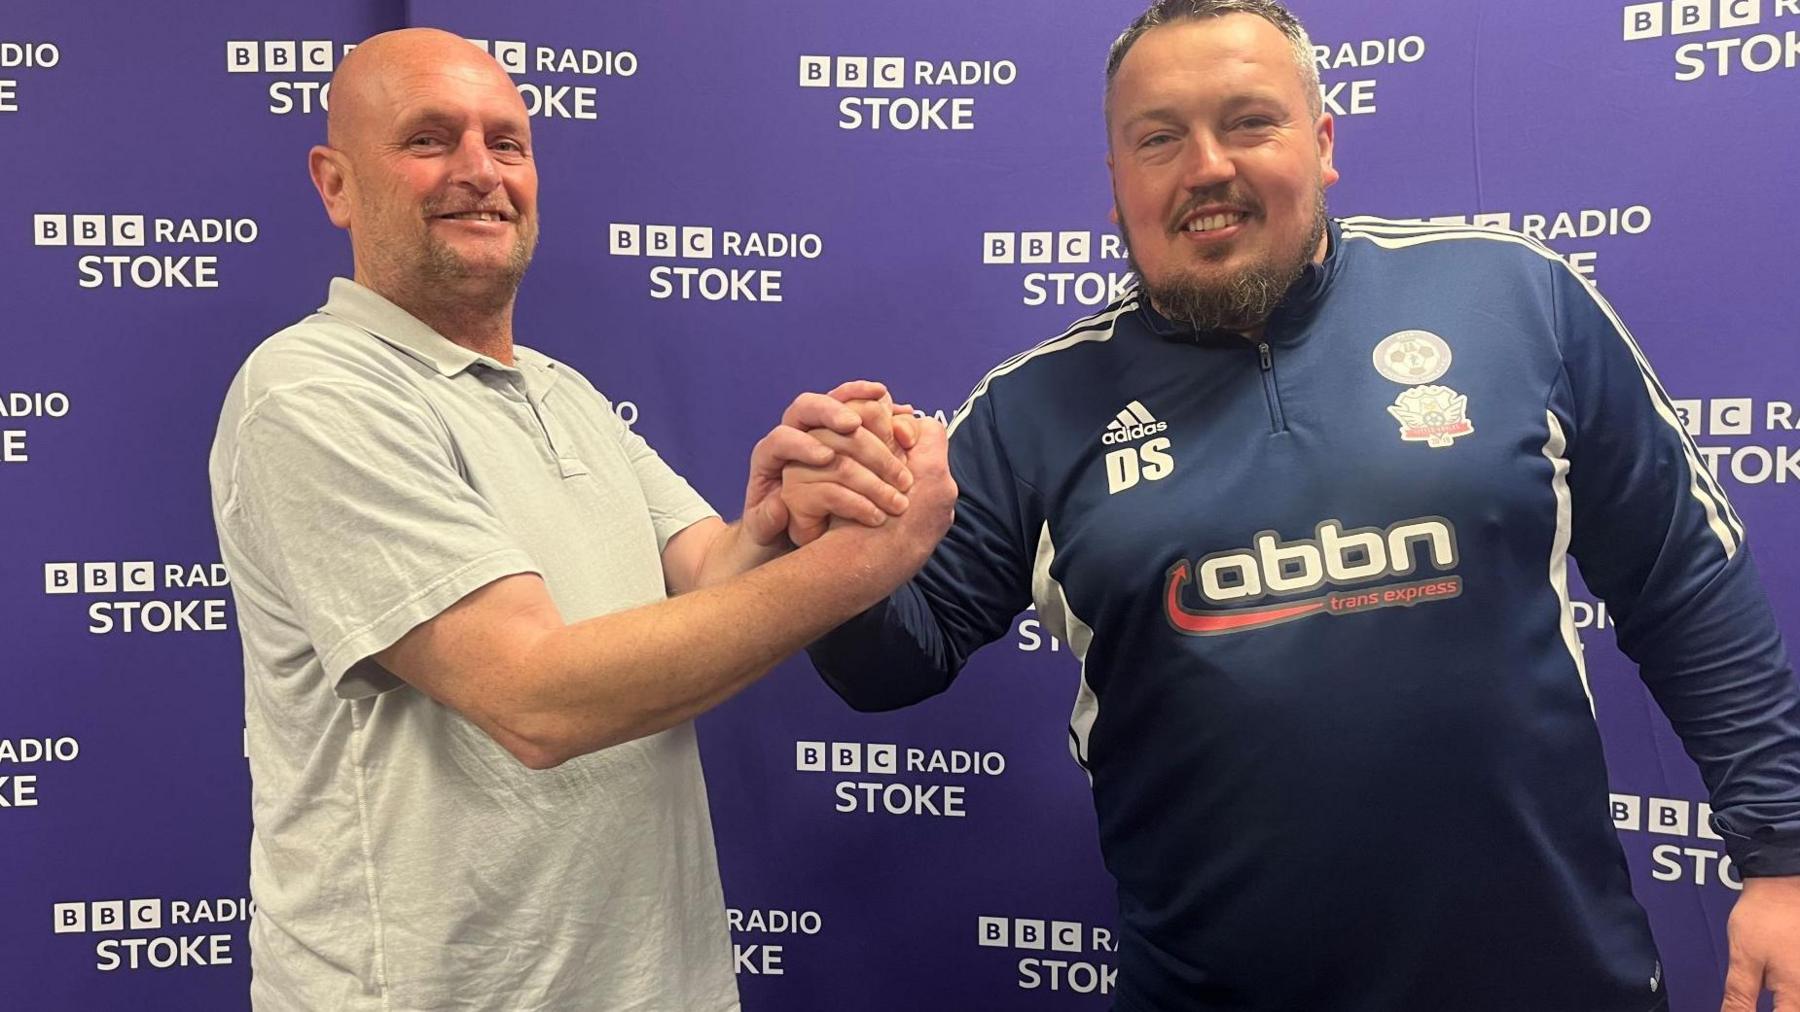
[607,221,824,303]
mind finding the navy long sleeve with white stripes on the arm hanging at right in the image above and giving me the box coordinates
[1548,263,1800,875]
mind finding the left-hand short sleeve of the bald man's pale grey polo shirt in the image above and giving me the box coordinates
[220,380,538,699]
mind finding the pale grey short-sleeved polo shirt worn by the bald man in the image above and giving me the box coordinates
[211,279,738,1012]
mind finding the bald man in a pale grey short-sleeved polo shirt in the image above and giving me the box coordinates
[211,31,956,1012]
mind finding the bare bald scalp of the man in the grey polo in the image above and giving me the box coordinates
[326,29,526,151]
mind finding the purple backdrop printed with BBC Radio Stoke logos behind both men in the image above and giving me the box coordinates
[0,0,1800,1012]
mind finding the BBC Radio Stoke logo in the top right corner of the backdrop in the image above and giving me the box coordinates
[1624,0,1800,83]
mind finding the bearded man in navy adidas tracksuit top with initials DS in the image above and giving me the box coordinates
[788,0,1800,1012]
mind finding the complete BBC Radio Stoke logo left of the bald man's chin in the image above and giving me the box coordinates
[31,212,261,288]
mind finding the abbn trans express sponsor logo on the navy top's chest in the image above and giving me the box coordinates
[1163,517,1462,636]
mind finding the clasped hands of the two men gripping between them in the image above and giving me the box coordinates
[743,380,956,569]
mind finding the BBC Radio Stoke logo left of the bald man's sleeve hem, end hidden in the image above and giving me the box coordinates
[43,560,230,636]
